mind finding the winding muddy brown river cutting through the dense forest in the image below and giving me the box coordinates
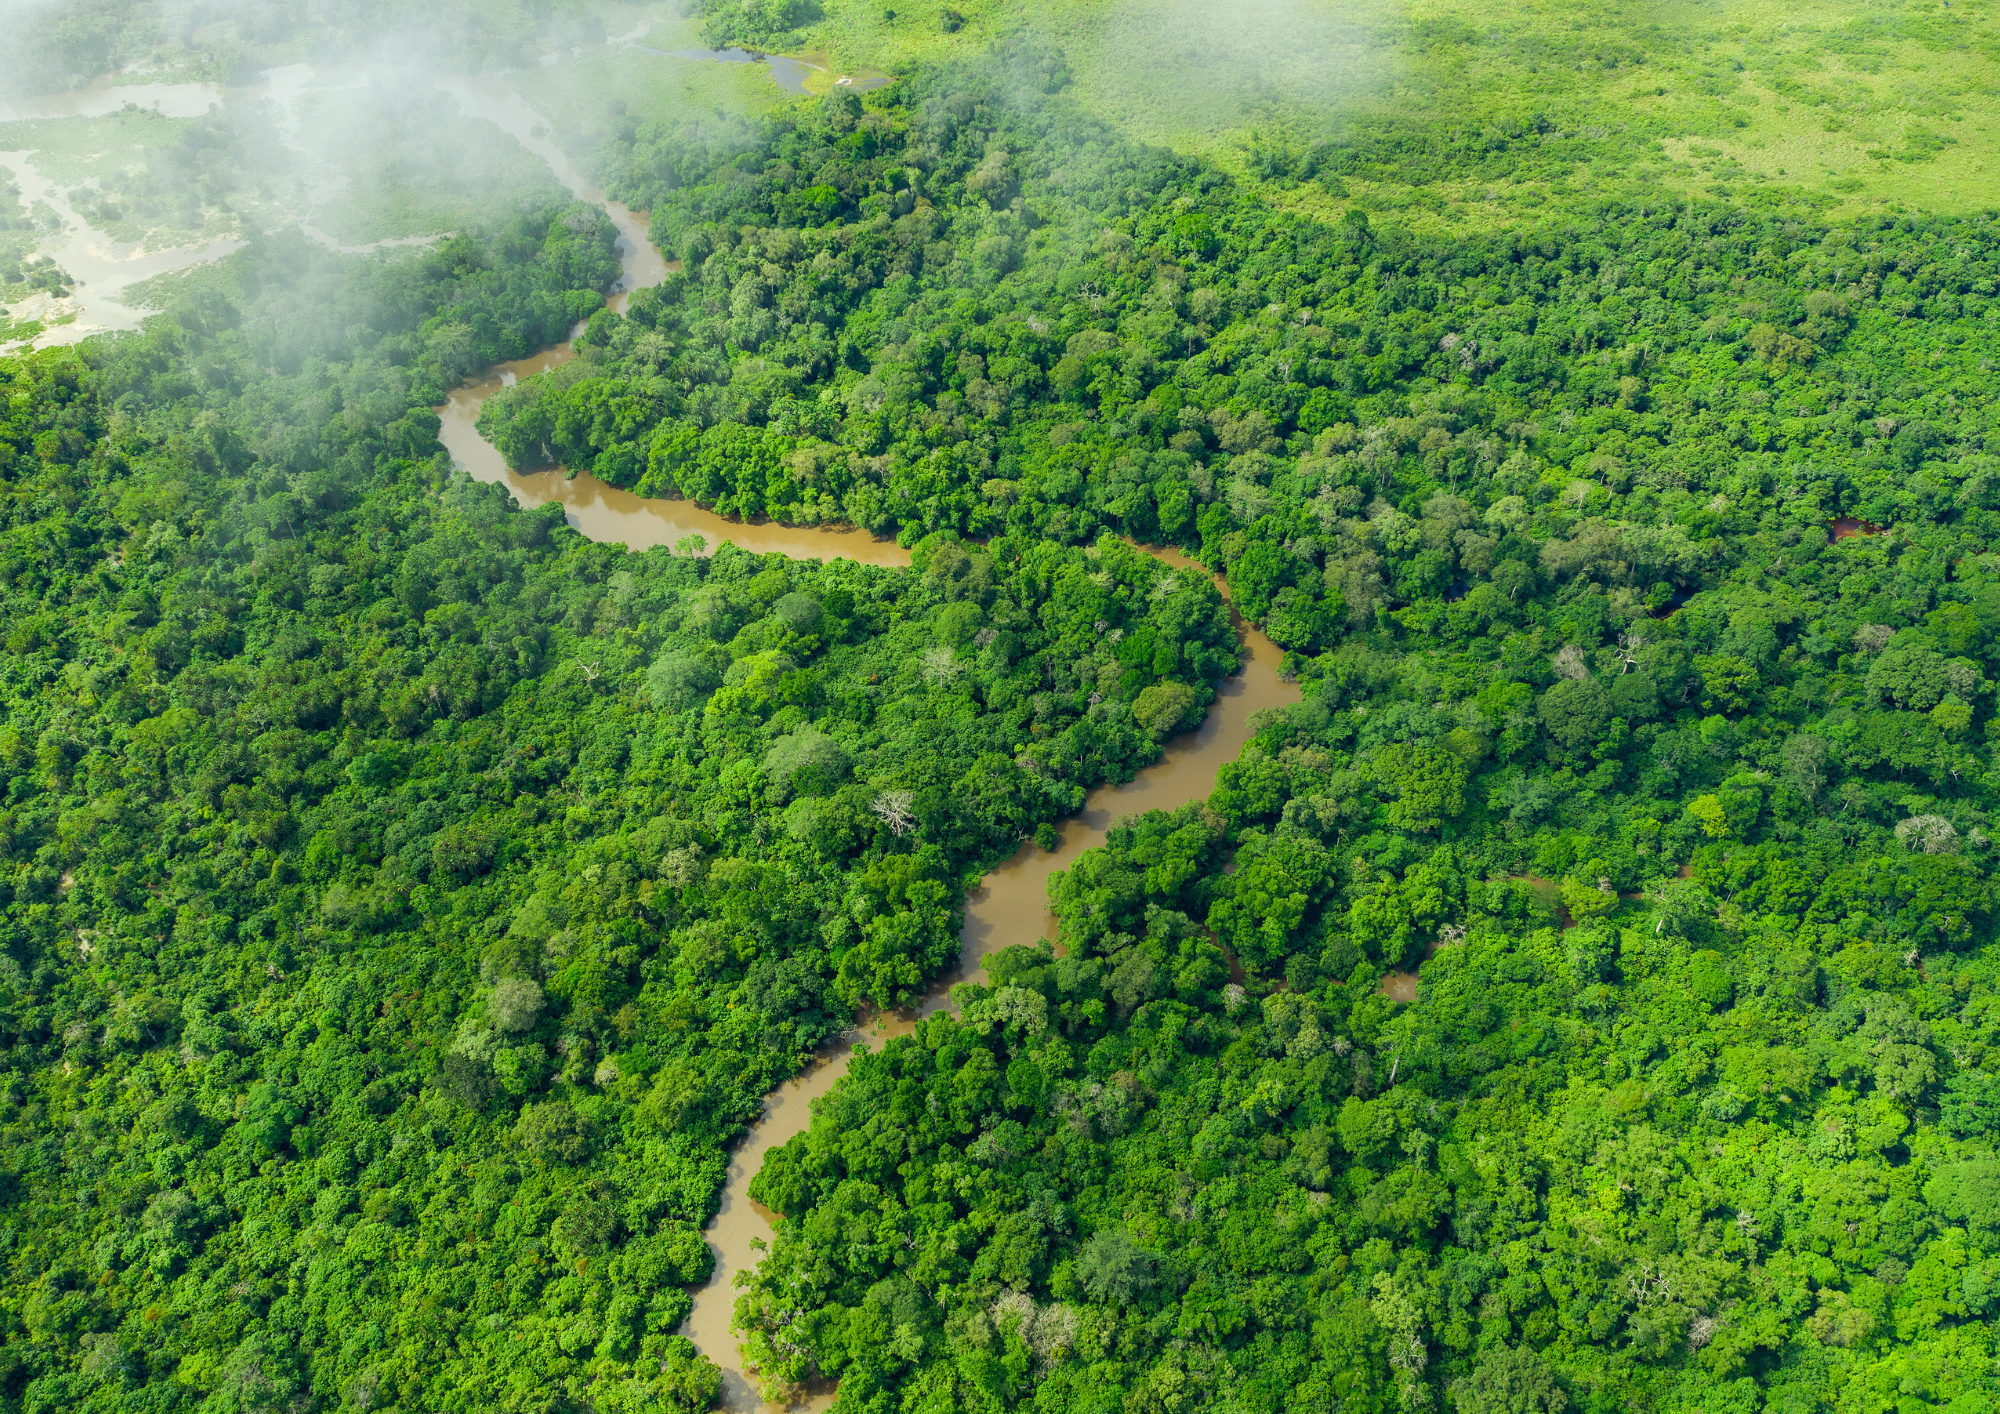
[438,97,1300,1414]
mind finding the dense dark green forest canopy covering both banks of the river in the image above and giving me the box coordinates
[0,22,2000,1414]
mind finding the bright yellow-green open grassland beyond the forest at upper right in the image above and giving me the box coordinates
[744,0,2000,226]
